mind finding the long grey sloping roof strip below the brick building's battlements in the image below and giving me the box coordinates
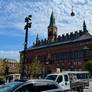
[27,33,92,50]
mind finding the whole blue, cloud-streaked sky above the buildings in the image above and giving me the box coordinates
[0,0,92,61]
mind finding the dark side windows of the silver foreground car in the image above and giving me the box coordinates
[15,83,58,92]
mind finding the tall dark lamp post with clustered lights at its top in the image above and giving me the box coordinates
[21,15,32,80]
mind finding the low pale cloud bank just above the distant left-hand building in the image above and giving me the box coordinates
[0,50,19,61]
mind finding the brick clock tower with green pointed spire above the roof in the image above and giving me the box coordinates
[48,11,57,42]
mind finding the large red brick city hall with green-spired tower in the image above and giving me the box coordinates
[21,11,92,72]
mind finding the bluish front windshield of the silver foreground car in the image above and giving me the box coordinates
[0,82,23,92]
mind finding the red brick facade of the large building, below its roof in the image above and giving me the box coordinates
[24,40,92,71]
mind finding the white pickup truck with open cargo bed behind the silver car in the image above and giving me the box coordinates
[46,71,89,92]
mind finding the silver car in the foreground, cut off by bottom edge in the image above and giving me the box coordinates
[0,80,64,92]
